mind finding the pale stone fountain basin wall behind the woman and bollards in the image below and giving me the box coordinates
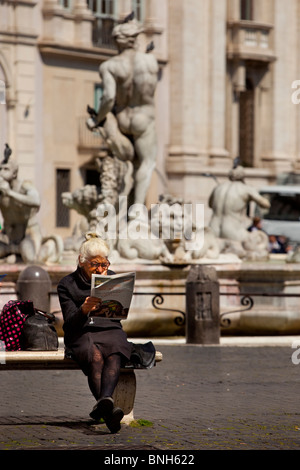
[0,253,300,337]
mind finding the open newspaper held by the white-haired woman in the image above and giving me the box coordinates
[90,272,135,320]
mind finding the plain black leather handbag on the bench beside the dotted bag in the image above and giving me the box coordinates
[21,308,58,351]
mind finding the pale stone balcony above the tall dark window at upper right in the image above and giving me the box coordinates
[227,21,275,62]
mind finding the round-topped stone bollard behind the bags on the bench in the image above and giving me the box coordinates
[17,266,52,313]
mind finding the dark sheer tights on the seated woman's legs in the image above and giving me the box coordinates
[88,345,121,400]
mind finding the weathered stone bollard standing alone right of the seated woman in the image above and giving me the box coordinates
[186,265,220,344]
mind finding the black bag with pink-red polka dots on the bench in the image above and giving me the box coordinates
[0,300,33,351]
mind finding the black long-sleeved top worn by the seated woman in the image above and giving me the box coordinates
[57,267,122,345]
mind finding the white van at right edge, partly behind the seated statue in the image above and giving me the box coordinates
[255,185,300,243]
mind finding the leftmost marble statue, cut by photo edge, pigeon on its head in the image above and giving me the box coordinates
[0,147,63,263]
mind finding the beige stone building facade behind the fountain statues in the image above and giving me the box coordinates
[0,0,300,237]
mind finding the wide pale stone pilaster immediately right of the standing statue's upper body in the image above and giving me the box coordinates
[168,0,210,163]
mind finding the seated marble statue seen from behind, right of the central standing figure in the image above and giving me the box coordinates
[209,166,270,259]
